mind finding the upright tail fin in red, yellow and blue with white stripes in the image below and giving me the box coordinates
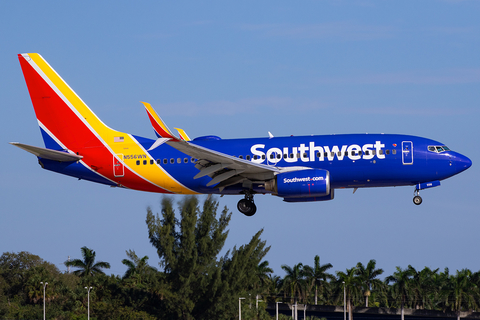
[18,53,122,152]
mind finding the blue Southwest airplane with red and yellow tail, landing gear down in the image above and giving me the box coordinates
[11,53,472,216]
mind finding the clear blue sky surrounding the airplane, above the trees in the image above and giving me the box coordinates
[0,0,480,275]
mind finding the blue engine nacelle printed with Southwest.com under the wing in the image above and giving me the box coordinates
[265,169,330,198]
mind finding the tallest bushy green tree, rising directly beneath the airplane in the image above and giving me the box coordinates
[146,196,269,319]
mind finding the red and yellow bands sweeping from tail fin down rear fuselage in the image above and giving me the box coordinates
[19,53,195,193]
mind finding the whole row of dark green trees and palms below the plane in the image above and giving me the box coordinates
[0,197,480,320]
